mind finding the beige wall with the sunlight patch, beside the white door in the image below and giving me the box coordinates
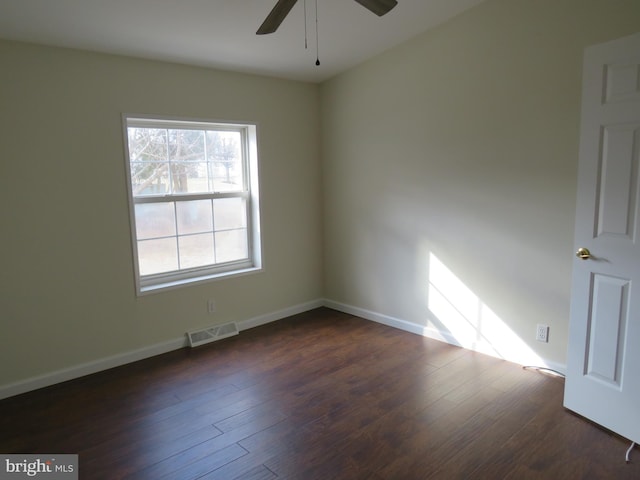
[321,0,640,366]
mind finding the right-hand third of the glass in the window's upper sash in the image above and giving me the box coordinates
[207,131,244,192]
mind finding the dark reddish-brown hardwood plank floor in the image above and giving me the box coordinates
[0,308,640,480]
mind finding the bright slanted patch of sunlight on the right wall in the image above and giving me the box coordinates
[428,253,542,365]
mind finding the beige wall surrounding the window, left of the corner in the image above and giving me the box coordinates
[0,42,322,386]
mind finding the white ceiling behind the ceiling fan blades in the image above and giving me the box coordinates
[0,0,483,82]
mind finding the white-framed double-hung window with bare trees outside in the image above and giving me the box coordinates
[124,116,260,293]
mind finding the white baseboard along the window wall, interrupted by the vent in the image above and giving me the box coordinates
[0,300,324,400]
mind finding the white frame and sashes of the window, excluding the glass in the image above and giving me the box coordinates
[122,114,262,295]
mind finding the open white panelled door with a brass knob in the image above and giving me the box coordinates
[564,33,640,443]
